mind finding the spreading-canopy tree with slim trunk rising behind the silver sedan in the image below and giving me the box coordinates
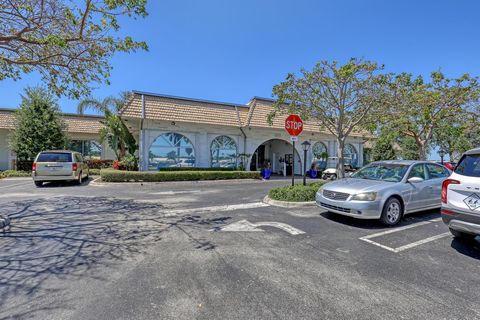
[268,59,387,178]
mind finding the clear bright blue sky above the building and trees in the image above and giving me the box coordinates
[0,0,480,159]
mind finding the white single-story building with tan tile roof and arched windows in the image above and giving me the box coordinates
[0,91,365,175]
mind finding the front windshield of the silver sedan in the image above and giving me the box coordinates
[351,163,408,182]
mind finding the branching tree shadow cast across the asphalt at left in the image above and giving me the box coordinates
[0,197,229,319]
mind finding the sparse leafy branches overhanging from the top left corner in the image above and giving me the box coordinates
[0,0,148,98]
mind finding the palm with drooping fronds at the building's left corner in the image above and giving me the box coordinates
[77,92,138,160]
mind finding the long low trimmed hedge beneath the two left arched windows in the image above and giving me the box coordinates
[100,169,260,182]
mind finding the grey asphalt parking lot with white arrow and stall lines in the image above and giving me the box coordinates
[0,178,480,319]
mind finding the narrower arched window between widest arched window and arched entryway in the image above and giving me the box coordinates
[210,136,237,168]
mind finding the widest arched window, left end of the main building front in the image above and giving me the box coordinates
[148,132,195,171]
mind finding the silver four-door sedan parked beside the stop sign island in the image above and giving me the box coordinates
[316,160,450,225]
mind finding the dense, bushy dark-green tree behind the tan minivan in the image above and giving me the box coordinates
[9,87,69,160]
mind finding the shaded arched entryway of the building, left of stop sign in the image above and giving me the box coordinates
[250,139,302,176]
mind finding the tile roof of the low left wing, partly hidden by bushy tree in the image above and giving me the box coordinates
[0,109,103,133]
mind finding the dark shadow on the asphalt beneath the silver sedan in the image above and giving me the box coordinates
[320,210,440,230]
